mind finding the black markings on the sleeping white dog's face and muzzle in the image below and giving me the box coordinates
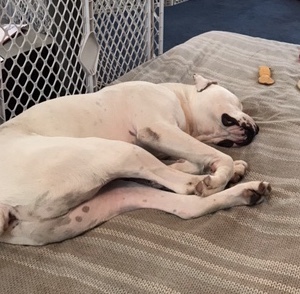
[218,113,259,147]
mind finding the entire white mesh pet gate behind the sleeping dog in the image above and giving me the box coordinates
[0,0,163,123]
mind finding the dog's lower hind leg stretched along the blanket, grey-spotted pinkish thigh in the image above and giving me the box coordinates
[0,180,270,245]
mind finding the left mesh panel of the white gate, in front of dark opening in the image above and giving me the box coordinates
[0,0,91,120]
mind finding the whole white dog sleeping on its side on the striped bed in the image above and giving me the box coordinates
[0,75,270,245]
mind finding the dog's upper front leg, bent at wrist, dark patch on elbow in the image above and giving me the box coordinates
[137,123,235,196]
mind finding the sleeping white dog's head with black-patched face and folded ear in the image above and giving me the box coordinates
[193,74,259,147]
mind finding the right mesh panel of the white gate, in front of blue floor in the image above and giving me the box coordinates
[94,0,163,87]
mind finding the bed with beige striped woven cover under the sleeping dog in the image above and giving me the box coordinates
[0,31,300,294]
